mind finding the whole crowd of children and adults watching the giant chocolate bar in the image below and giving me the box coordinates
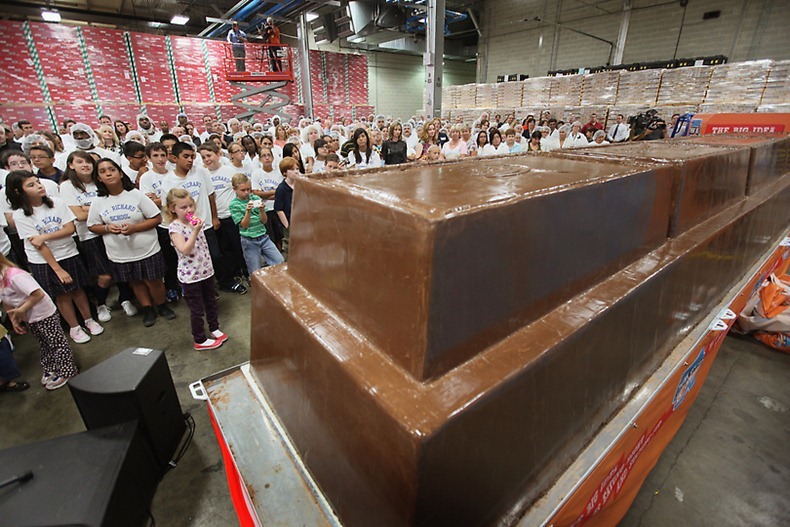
[0,105,680,391]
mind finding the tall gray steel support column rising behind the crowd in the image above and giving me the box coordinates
[423,0,445,117]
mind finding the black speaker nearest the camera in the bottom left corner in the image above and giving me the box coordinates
[0,421,161,527]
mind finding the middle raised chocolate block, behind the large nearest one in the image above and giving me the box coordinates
[551,141,749,237]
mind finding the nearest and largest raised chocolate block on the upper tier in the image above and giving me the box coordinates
[289,156,672,379]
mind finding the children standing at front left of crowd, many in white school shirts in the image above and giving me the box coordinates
[0,136,300,391]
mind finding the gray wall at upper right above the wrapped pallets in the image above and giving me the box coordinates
[478,0,790,82]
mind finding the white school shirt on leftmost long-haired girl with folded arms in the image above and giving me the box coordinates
[14,196,79,264]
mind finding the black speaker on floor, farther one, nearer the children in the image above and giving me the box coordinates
[69,348,186,472]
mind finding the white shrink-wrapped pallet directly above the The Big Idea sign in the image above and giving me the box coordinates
[705,60,774,106]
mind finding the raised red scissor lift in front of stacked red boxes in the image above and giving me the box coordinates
[223,43,294,122]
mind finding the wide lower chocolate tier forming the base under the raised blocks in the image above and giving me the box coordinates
[251,171,790,526]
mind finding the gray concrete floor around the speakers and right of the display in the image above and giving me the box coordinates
[0,293,790,527]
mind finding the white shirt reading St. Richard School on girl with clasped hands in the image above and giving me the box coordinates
[88,189,161,263]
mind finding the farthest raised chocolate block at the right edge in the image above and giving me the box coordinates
[674,134,790,194]
